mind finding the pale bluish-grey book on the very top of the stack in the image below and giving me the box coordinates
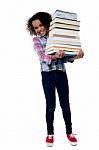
[52,9,77,20]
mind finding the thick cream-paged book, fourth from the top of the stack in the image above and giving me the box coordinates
[49,28,79,37]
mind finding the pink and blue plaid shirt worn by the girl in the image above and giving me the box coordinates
[33,36,66,72]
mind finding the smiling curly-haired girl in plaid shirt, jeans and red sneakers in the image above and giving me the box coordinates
[27,12,84,146]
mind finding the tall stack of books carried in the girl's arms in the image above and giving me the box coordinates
[45,10,81,58]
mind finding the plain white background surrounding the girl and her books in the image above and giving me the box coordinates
[0,0,99,150]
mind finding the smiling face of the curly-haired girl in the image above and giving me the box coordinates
[32,19,48,36]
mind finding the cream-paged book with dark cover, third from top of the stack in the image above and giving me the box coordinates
[49,22,80,31]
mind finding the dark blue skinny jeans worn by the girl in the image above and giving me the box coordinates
[41,70,72,134]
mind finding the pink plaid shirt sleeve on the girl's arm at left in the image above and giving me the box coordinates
[33,37,52,64]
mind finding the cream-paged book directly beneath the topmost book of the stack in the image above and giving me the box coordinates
[50,17,80,26]
